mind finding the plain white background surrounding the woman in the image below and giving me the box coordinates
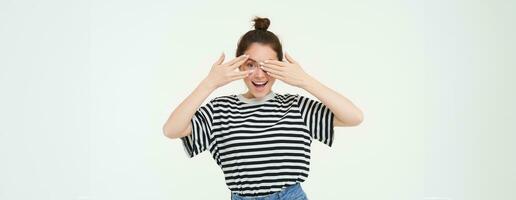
[0,0,516,200]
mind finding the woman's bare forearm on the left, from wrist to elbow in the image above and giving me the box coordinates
[163,79,216,138]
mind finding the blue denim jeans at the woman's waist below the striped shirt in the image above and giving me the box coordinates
[231,182,308,200]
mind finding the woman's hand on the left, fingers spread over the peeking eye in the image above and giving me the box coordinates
[204,53,254,88]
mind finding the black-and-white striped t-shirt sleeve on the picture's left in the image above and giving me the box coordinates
[181,100,214,158]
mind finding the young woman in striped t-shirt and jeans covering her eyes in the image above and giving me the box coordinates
[163,17,363,199]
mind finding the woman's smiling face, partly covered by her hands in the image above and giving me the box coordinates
[240,43,278,98]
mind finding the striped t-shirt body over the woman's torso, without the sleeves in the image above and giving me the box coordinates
[210,93,312,196]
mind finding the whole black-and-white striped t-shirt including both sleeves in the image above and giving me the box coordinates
[181,92,334,197]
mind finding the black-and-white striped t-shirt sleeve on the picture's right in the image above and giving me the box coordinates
[297,95,334,147]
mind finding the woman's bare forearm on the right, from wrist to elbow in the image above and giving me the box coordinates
[302,77,363,126]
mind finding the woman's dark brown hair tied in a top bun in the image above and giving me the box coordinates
[236,17,283,61]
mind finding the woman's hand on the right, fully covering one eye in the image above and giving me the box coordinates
[260,53,312,88]
